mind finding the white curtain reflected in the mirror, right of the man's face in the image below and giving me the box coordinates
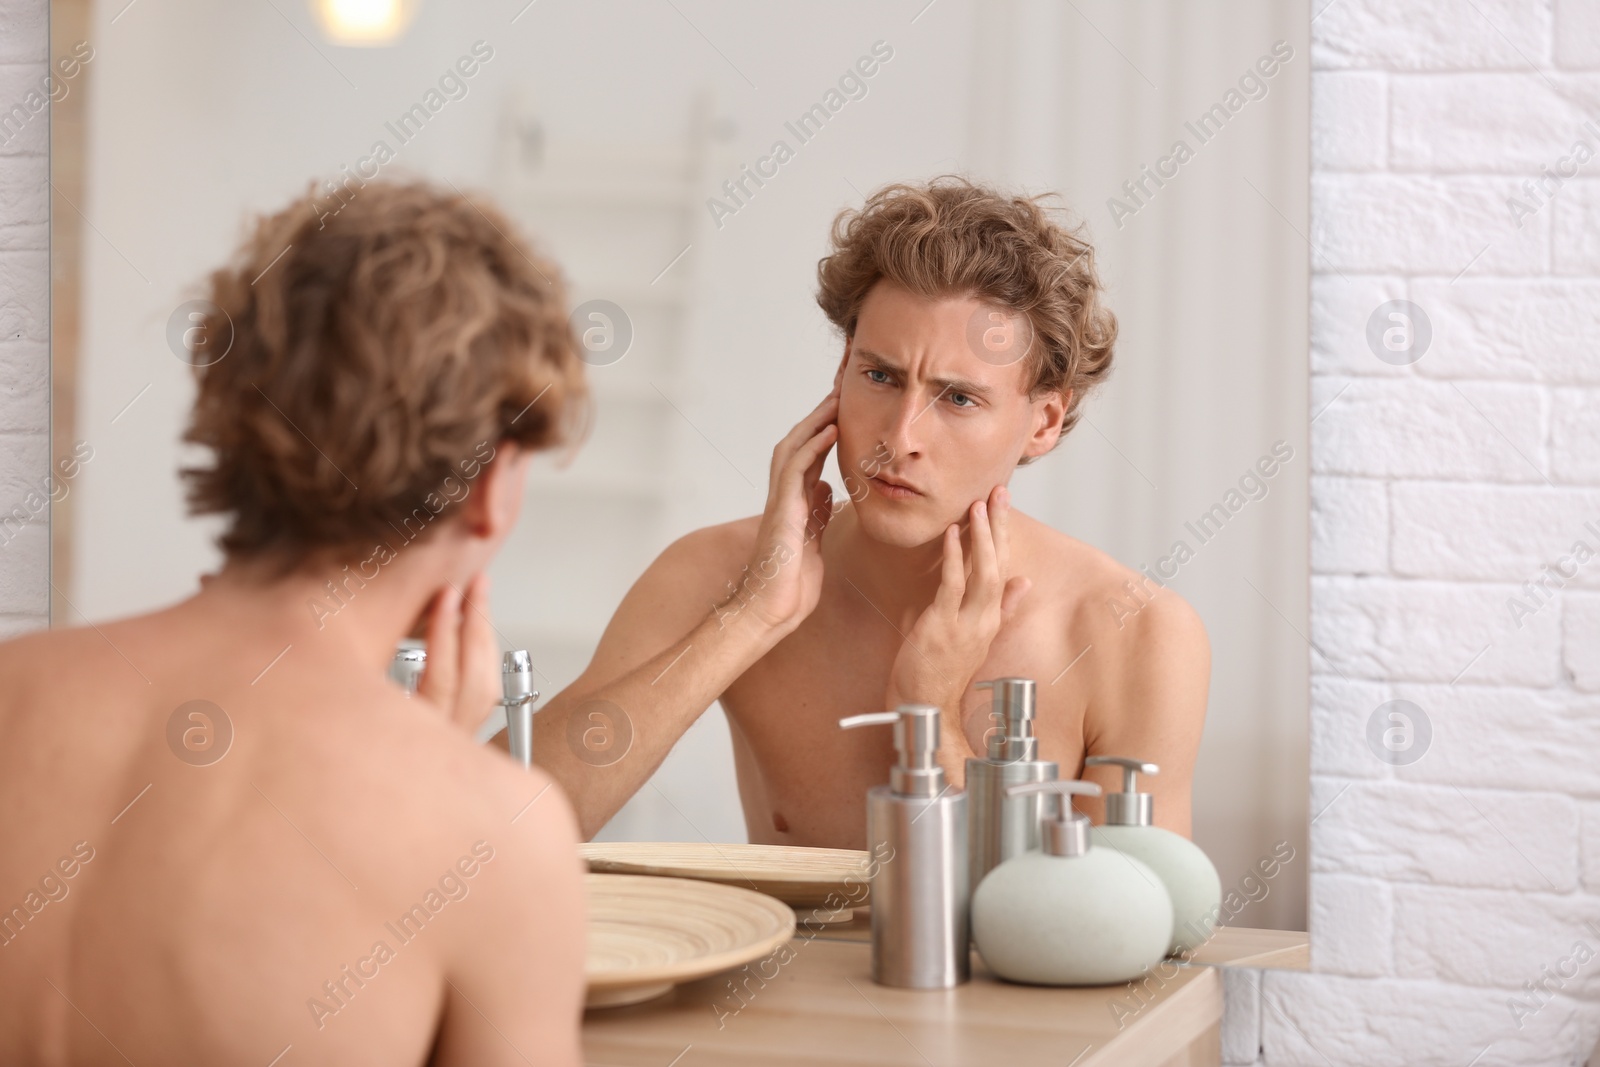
[970,0,1314,929]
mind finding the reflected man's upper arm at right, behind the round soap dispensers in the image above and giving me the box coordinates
[1061,589,1211,837]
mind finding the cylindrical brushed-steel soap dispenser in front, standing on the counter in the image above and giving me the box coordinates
[838,704,971,989]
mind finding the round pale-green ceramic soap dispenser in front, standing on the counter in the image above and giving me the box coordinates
[973,781,1173,985]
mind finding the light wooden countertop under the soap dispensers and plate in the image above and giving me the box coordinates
[584,915,1309,1067]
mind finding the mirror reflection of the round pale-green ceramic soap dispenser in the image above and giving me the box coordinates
[1083,755,1222,952]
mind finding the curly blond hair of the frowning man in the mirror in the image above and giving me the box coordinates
[816,174,1117,451]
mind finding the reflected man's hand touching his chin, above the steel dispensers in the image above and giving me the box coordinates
[885,486,1032,735]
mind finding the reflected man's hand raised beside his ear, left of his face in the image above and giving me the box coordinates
[729,389,838,638]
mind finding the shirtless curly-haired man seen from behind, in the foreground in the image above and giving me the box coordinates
[0,182,851,1065]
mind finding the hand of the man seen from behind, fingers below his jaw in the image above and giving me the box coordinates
[416,571,502,731]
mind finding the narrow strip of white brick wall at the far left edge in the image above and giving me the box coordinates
[0,0,50,638]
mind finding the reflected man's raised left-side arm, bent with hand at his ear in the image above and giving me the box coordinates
[496,390,838,840]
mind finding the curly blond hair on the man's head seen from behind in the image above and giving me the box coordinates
[181,181,589,573]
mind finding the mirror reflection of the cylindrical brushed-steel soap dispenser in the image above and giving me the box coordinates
[966,678,1061,891]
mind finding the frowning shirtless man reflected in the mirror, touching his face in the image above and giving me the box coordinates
[536,179,1210,848]
